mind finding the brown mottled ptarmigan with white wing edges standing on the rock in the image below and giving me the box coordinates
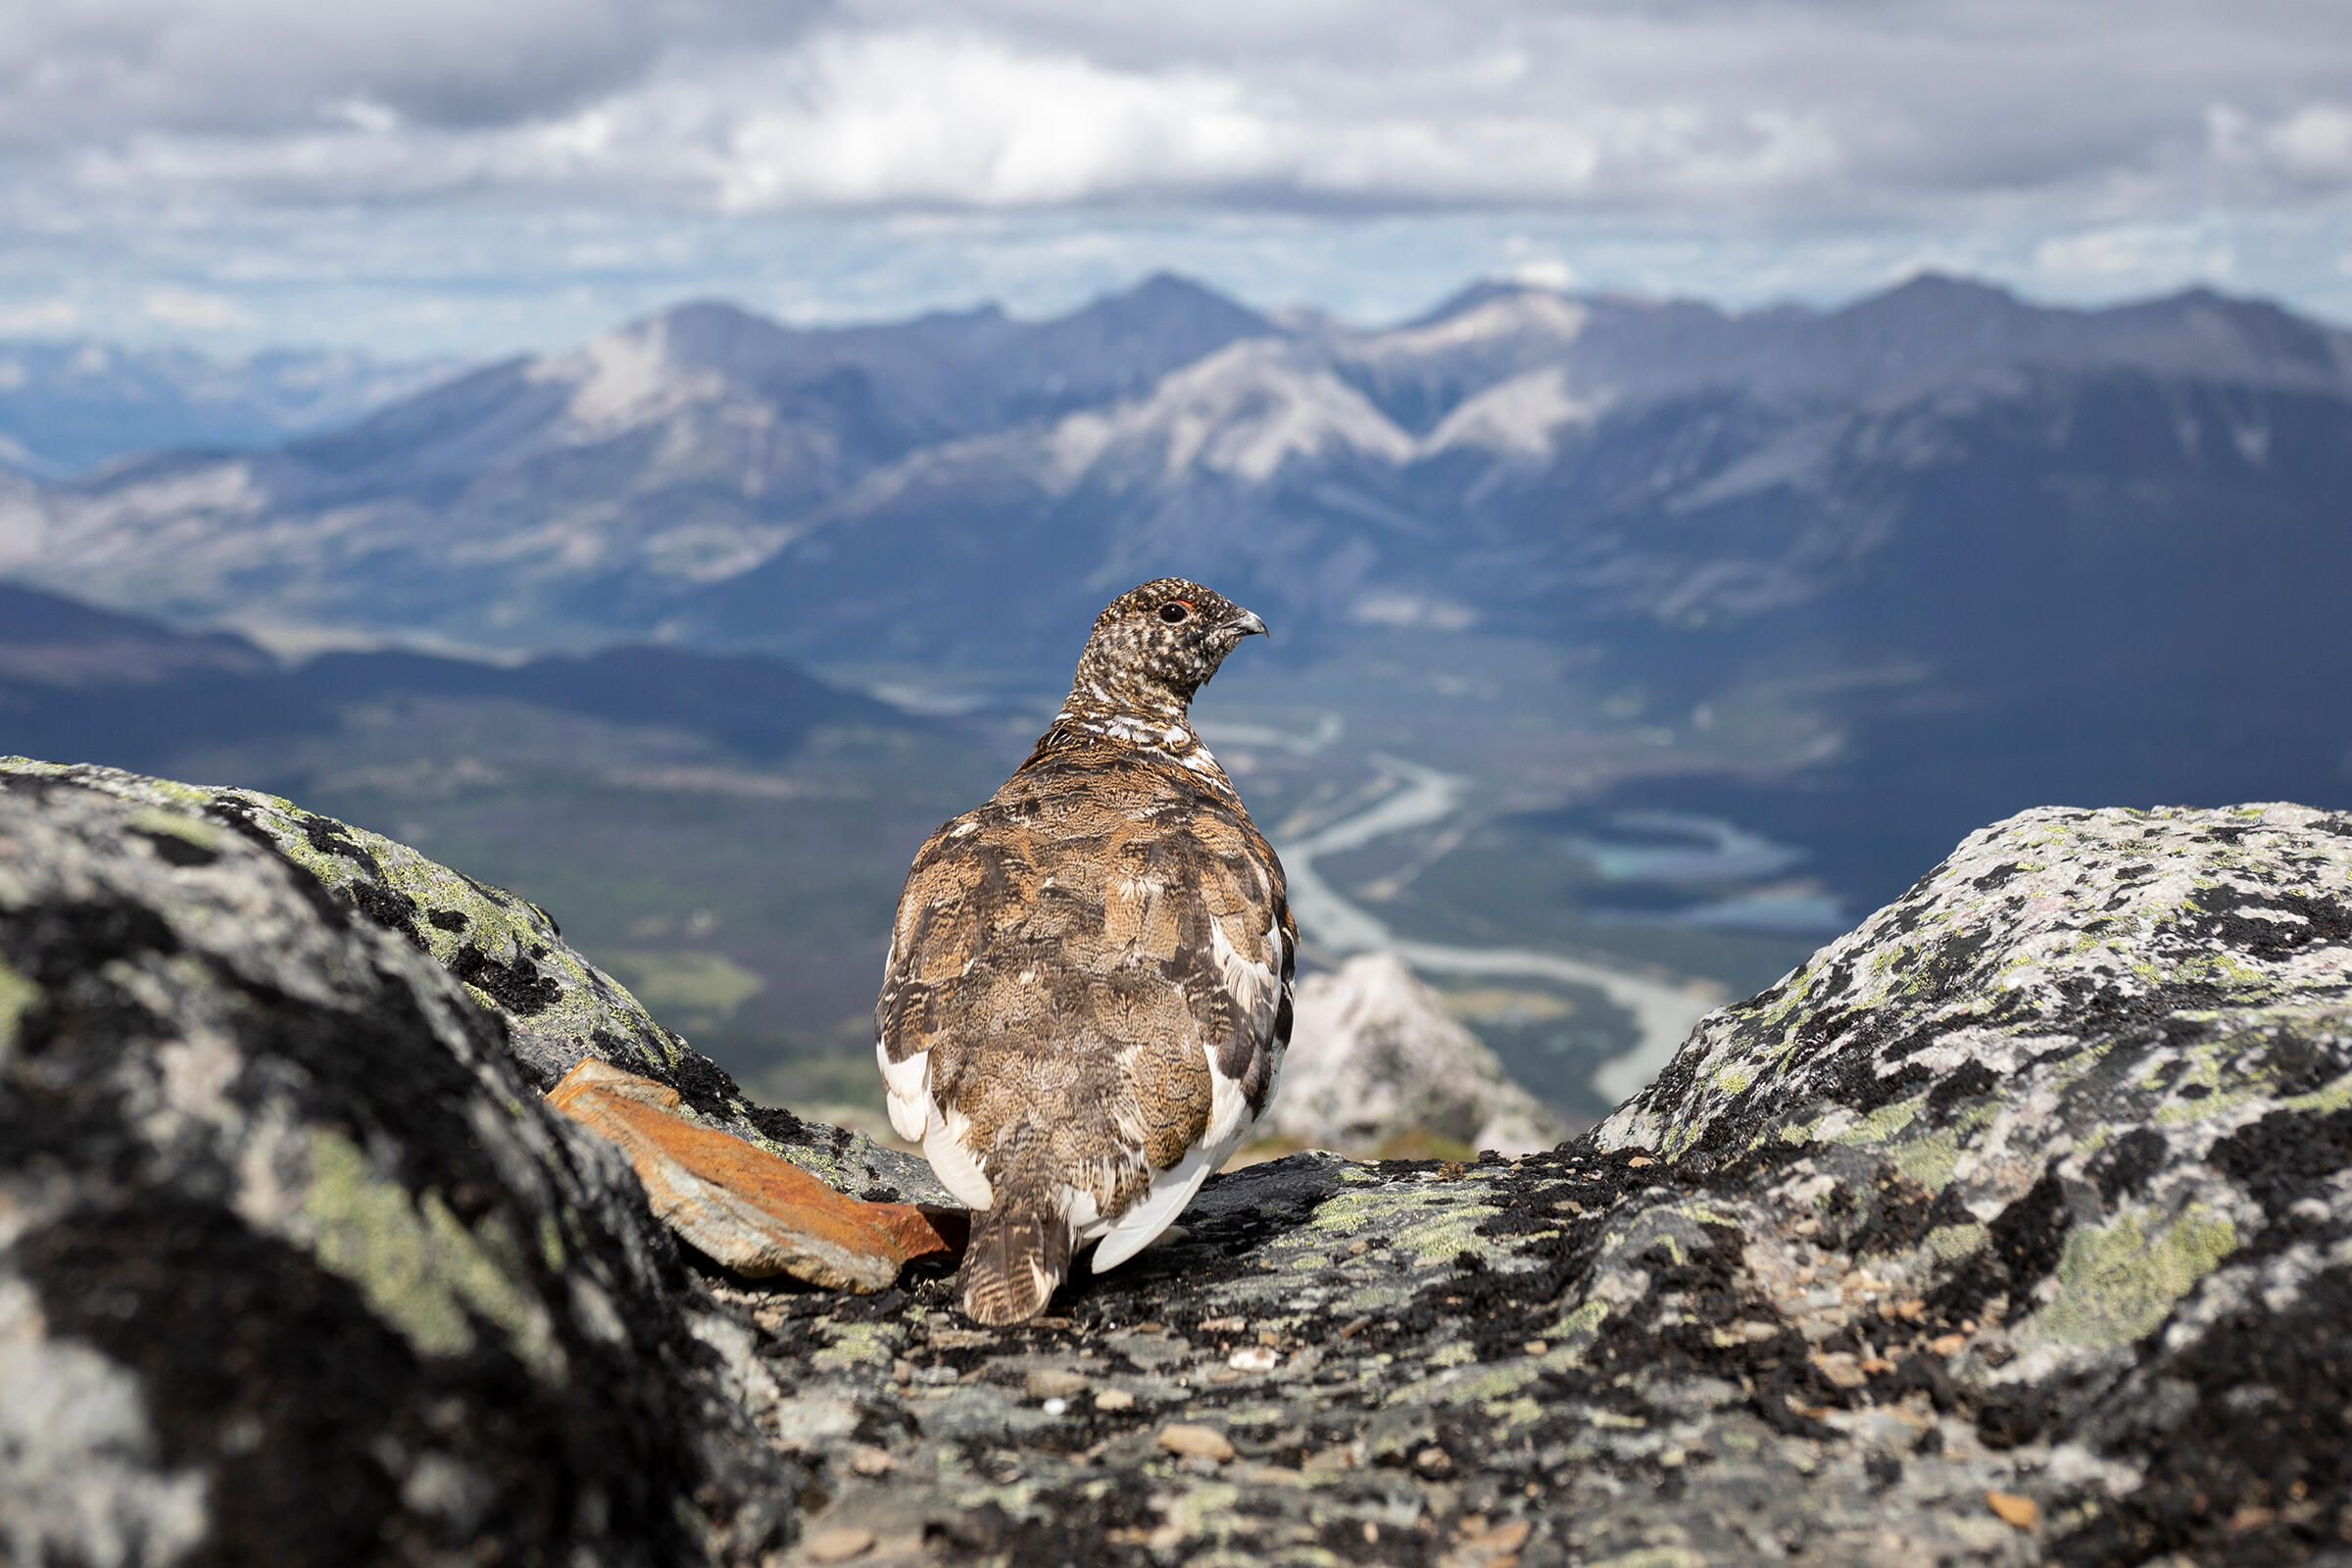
[875,578,1298,1324]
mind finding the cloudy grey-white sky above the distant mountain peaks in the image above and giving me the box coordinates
[0,0,2352,355]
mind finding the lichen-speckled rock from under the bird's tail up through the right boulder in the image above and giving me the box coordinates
[734,807,2352,1568]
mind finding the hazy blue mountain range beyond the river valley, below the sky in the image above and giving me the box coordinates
[0,275,2352,907]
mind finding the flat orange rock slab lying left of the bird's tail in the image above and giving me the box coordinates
[548,1060,966,1291]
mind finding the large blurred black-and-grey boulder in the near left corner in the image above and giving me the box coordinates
[0,768,798,1568]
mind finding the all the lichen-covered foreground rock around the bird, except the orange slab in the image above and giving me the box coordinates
[0,760,2352,1568]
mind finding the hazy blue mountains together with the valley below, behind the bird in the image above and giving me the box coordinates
[0,275,2352,1114]
